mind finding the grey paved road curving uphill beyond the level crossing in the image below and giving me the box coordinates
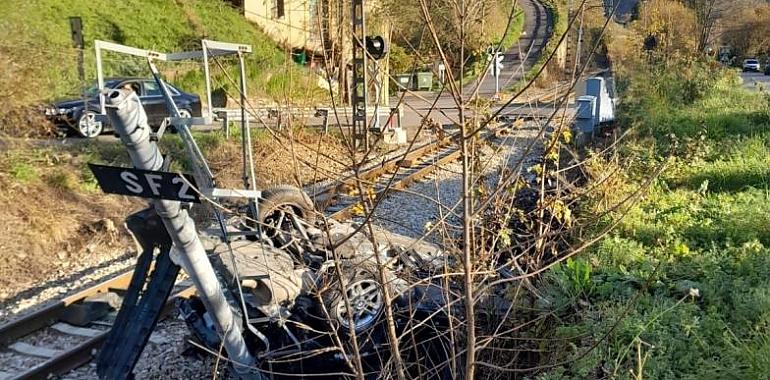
[390,0,552,128]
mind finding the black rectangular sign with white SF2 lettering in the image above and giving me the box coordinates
[88,164,200,203]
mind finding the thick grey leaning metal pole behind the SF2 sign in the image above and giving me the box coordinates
[107,90,261,379]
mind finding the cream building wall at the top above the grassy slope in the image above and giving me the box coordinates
[243,0,322,51]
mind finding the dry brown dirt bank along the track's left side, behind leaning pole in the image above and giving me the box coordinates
[0,131,349,305]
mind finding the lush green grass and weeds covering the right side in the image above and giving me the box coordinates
[539,65,770,379]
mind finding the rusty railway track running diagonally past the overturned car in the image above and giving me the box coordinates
[0,135,460,380]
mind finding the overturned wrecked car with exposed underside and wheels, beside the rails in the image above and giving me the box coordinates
[181,221,450,378]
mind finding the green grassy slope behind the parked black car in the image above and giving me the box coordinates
[0,0,322,99]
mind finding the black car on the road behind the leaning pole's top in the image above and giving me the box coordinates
[45,78,201,138]
